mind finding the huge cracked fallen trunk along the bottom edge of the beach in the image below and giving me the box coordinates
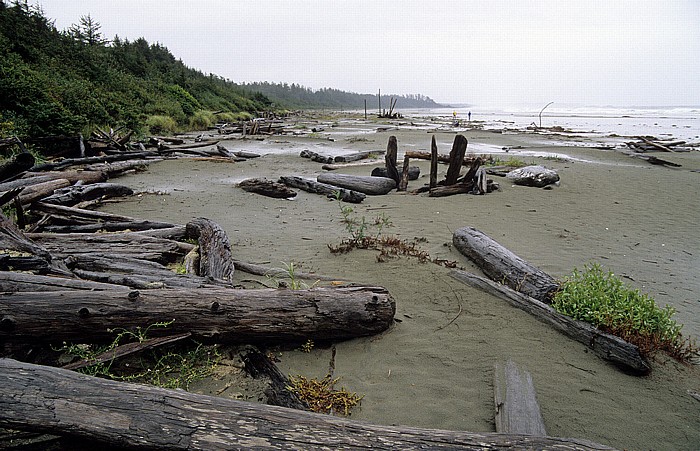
[0,359,610,450]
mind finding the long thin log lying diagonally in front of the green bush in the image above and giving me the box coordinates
[450,270,651,375]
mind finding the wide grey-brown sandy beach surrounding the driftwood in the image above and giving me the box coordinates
[102,116,700,449]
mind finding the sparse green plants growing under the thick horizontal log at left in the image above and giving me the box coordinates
[57,321,221,389]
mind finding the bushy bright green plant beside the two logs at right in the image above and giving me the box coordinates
[552,263,697,362]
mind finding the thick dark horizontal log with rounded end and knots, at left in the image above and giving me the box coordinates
[0,287,396,344]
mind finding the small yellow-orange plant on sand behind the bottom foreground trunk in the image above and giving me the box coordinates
[287,374,364,415]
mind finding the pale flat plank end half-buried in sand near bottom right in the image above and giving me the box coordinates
[493,359,547,436]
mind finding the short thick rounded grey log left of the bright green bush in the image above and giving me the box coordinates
[452,227,559,303]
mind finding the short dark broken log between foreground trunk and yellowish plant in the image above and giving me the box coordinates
[243,350,309,410]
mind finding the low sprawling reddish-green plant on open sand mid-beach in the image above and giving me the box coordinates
[328,193,457,268]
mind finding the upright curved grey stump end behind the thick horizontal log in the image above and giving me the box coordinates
[186,218,234,282]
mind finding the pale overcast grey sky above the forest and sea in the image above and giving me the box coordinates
[30,0,700,107]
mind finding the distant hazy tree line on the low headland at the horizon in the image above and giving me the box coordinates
[243,82,440,110]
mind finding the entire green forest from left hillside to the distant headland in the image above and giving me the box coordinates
[0,0,436,138]
